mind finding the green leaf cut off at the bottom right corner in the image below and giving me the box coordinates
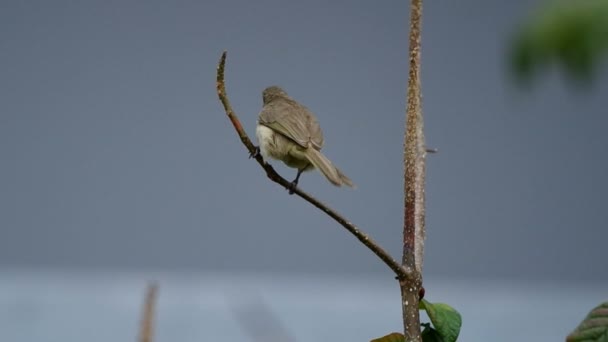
[566,302,608,342]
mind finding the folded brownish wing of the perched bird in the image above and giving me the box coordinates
[259,101,323,149]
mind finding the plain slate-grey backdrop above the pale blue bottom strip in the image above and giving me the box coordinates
[0,0,608,279]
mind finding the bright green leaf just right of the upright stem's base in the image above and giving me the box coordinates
[420,299,462,342]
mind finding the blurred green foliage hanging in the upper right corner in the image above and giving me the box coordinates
[510,0,608,81]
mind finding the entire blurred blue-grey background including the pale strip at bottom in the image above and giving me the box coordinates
[0,0,608,342]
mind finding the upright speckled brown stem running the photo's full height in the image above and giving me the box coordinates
[399,0,427,341]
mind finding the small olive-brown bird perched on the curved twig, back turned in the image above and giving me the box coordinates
[256,86,355,193]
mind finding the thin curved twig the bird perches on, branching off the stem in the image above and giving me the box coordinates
[217,51,413,279]
